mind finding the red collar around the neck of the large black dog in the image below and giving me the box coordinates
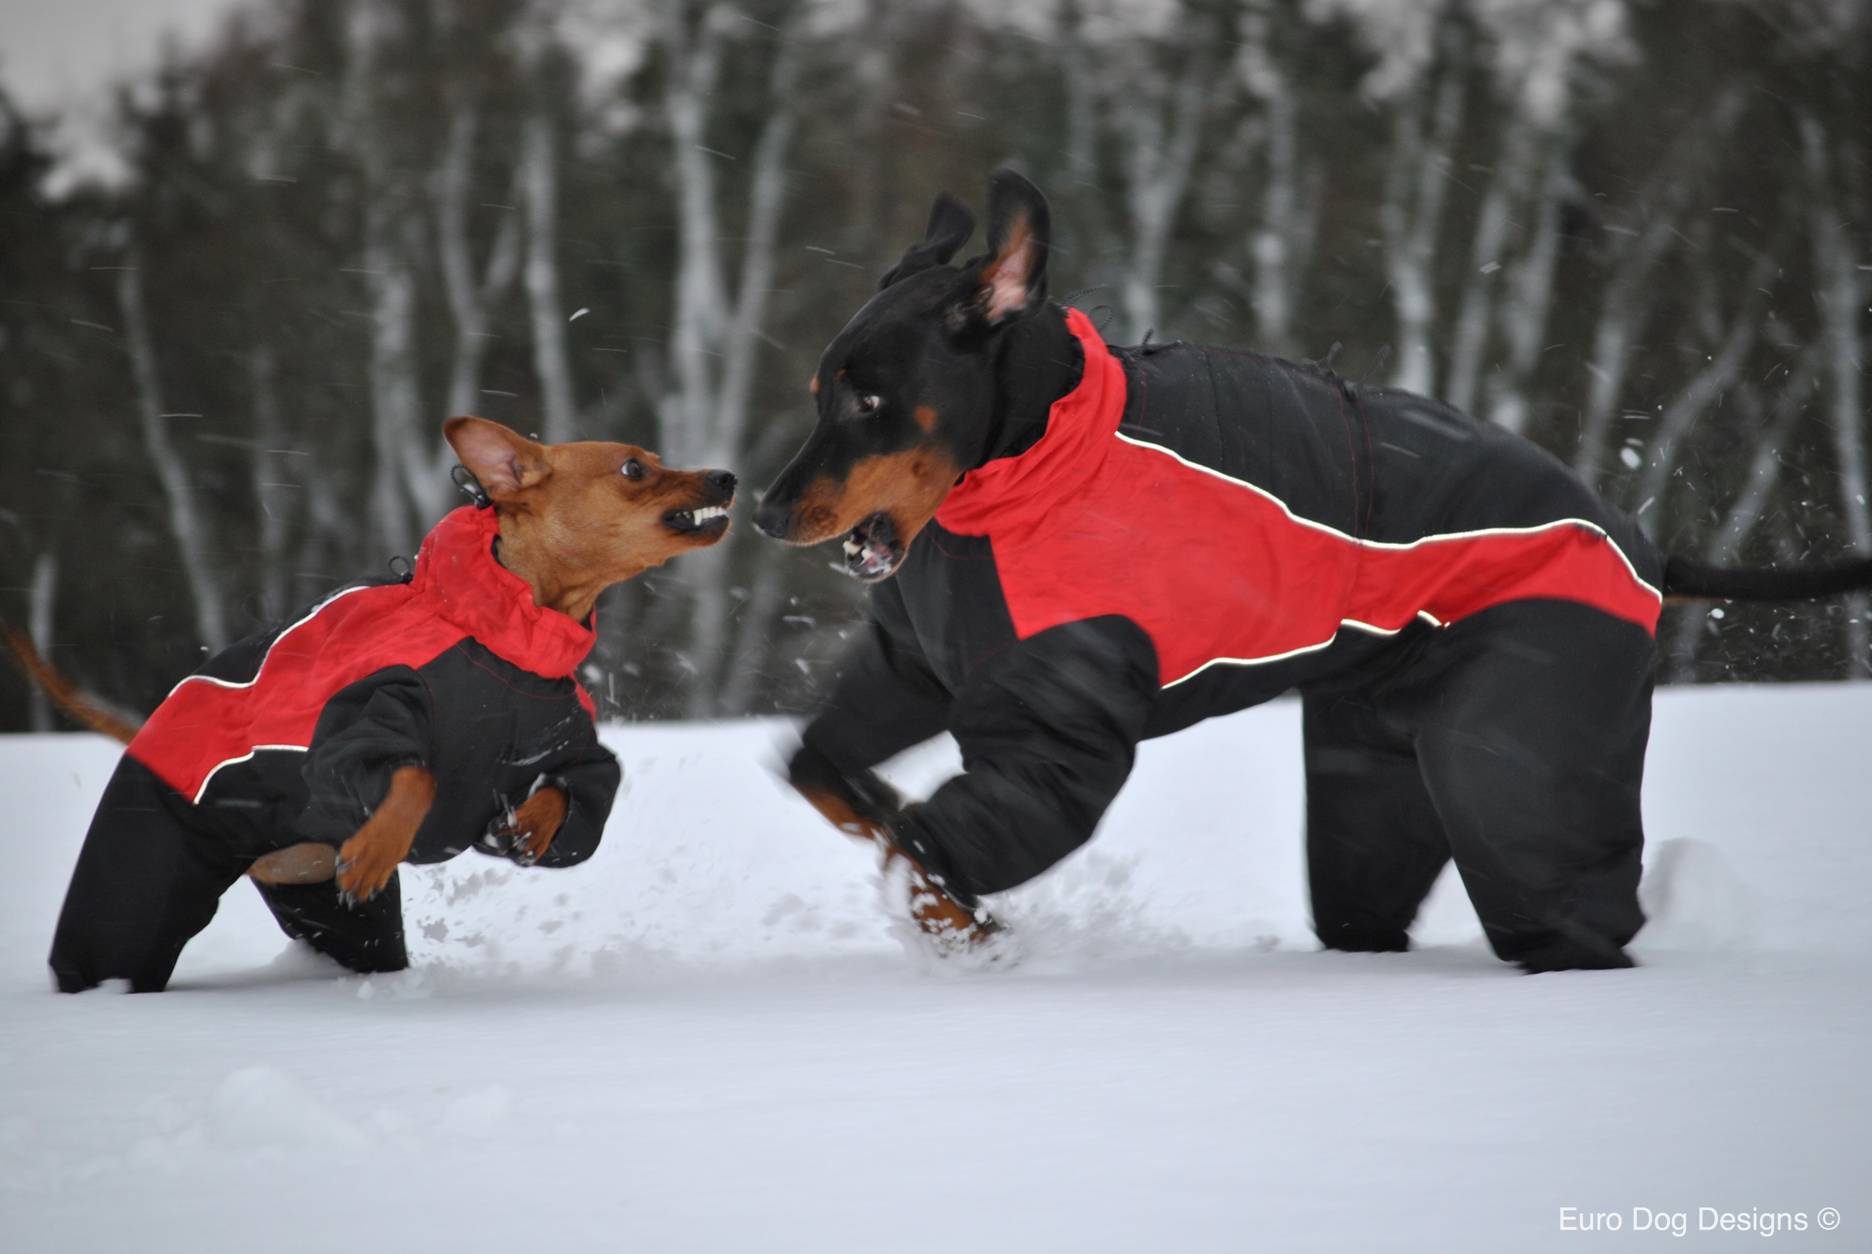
[936,309,1125,535]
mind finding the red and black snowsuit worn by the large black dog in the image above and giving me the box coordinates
[796,311,1662,970]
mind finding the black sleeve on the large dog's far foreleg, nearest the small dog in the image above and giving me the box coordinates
[801,580,949,775]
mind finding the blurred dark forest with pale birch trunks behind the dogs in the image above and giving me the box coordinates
[0,0,1872,728]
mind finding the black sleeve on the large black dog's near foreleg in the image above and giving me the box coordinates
[895,618,1157,895]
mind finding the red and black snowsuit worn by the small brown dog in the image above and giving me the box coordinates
[51,507,620,992]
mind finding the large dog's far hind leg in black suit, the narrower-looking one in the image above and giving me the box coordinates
[1303,694,1449,953]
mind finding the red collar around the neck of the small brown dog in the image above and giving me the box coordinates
[410,505,597,679]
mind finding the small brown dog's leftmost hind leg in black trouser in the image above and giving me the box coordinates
[51,756,243,992]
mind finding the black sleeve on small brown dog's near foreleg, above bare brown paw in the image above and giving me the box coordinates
[294,666,434,844]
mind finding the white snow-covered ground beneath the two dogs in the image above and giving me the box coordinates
[0,685,1872,1254]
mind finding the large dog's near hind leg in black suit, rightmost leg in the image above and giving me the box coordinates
[1415,601,1657,971]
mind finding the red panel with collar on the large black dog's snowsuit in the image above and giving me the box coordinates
[936,311,1660,687]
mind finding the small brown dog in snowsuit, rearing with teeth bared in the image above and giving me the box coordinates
[32,417,736,992]
